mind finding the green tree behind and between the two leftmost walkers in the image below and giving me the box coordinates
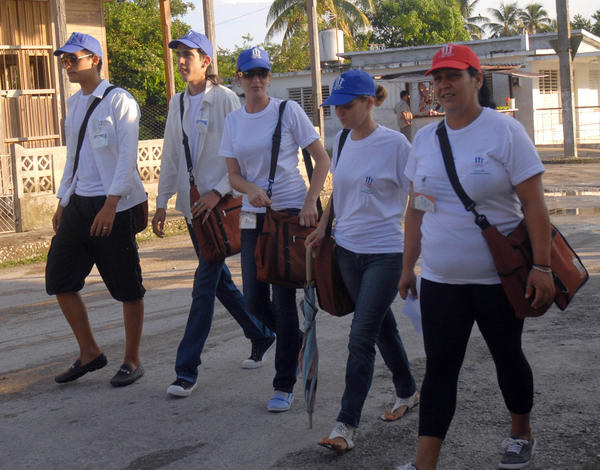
[104,0,194,139]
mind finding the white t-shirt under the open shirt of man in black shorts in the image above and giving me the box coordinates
[72,94,106,197]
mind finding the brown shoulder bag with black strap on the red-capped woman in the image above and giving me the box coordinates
[437,121,589,318]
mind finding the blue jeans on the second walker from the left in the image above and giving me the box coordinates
[175,225,274,382]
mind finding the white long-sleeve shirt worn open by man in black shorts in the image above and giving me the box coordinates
[57,80,147,212]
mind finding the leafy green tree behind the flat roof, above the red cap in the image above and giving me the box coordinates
[370,0,469,48]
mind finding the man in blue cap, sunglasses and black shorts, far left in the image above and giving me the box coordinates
[46,33,147,387]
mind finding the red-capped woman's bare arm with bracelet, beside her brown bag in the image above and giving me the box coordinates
[515,173,554,308]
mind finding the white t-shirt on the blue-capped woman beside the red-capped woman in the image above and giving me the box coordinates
[331,126,410,253]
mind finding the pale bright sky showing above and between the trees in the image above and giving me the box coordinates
[184,0,600,49]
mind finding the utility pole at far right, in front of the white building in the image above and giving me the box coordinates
[556,0,577,158]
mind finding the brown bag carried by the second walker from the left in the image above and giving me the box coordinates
[190,185,242,261]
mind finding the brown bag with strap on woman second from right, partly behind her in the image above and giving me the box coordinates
[312,129,354,317]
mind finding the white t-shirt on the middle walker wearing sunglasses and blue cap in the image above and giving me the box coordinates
[219,98,319,212]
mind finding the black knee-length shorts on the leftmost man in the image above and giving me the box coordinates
[46,194,146,302]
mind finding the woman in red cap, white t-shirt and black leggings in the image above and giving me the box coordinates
[398,44,554,470]
